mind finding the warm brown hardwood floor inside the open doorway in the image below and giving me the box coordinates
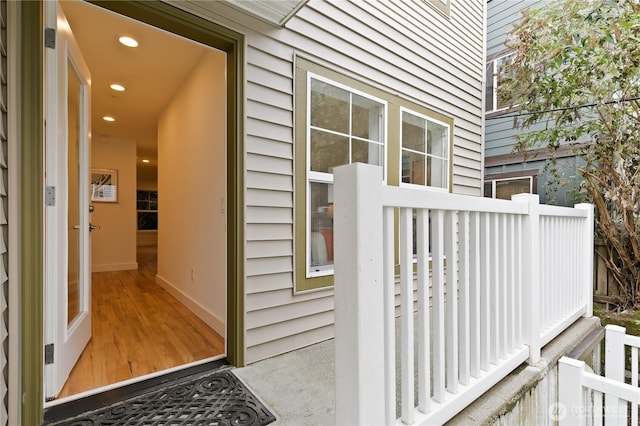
[58,247,224,398]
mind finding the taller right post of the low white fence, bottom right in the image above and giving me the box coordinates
[604,324,627,425]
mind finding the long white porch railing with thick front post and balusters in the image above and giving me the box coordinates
[334,164,593,425]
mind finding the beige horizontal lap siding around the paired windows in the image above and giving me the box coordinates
[172,0,485,362]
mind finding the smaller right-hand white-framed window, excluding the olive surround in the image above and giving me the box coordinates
[400,109,449,190]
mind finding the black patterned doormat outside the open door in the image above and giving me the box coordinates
[48,370,276,426]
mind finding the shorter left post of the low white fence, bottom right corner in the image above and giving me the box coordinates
[549,356,597,426]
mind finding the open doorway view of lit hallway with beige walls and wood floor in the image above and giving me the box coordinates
[47,1,229,400]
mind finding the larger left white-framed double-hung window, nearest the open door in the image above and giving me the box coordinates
[307,74,386,277]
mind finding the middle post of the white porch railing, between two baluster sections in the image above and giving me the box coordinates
[511,194,541,364]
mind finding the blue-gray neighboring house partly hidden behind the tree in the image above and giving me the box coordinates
[484,0,581,206]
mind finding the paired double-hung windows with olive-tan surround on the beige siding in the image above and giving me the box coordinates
[294,56,453,292]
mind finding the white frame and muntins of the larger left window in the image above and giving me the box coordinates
[305,72,389,278]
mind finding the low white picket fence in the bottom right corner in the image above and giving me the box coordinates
[556,325,640,426]
